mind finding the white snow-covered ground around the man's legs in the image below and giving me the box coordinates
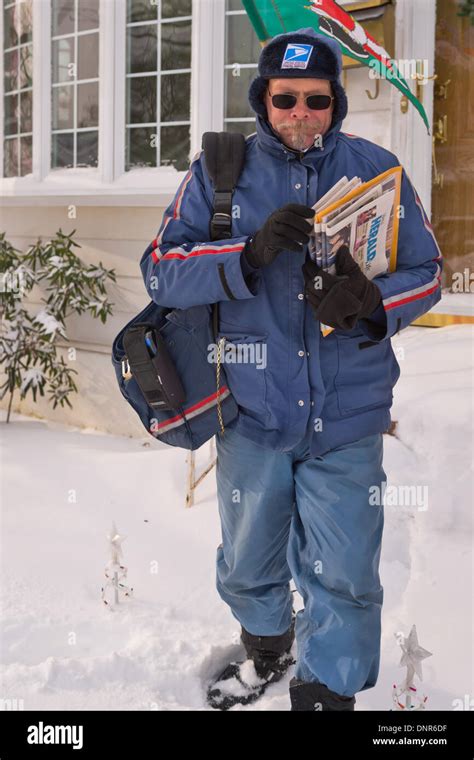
[0,325,474,710]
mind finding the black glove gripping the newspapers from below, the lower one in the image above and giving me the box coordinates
[302,245,382,330]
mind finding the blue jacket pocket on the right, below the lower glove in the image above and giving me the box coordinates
[334,334,400,416]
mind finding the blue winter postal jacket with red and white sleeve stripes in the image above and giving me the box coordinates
[140,116,442,456]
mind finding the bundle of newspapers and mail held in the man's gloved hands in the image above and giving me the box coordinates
[308,166,402,336]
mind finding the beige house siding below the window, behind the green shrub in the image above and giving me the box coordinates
[0,205,159,436]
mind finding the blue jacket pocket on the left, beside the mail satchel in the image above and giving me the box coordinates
[217,325,267,415]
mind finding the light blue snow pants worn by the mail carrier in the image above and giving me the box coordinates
[216,430,386,696]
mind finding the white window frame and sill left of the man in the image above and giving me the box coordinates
[0,0,217,206]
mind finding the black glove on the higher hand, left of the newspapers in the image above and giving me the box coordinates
[243,203,314,268]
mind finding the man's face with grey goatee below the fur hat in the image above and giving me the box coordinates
[265,78,334,150]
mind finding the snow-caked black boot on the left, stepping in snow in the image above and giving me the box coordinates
[207,614,295,710]
